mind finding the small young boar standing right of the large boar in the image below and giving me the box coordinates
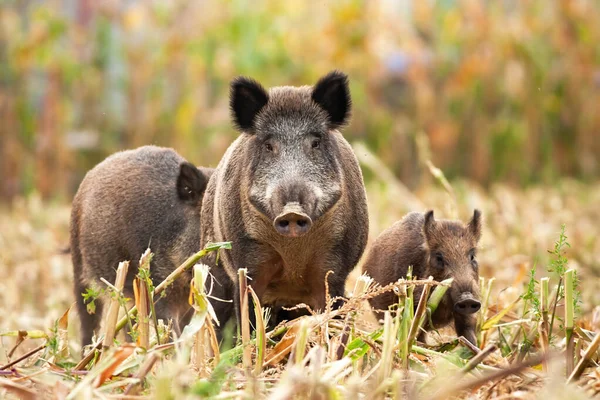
[363,210,481,344]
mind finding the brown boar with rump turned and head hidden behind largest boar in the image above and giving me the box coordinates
[71,146,213,344]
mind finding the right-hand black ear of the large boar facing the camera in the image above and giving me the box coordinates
[312,71,352,129]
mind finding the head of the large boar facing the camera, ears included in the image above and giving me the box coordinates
[230,71,351,237]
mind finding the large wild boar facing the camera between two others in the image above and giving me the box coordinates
[201,72,368,325]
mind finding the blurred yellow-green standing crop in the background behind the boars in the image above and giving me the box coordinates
[0,0,600,199]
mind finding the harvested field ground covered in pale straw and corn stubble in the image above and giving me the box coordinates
[0,177,600,399]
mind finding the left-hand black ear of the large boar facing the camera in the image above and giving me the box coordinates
[229,76,269,132]
